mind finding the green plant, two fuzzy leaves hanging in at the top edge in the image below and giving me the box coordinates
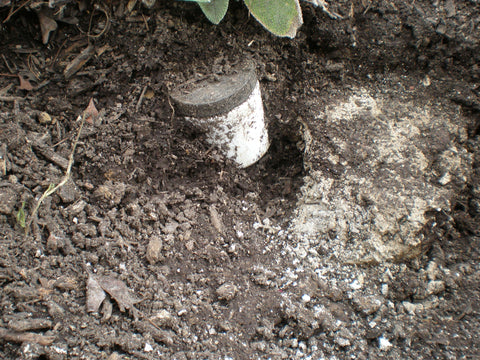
[189,0,303,38]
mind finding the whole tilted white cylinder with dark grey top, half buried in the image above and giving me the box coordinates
[171,69,269,168]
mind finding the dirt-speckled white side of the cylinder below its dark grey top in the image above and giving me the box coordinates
[186,81,269,168]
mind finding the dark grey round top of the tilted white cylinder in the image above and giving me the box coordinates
[170,67,257,118]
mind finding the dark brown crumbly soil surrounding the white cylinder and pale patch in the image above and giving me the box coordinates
[0,0,480,360]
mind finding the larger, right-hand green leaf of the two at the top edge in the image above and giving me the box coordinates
[244,0,303,38]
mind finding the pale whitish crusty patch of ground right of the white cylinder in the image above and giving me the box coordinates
[290,90,472,267]
